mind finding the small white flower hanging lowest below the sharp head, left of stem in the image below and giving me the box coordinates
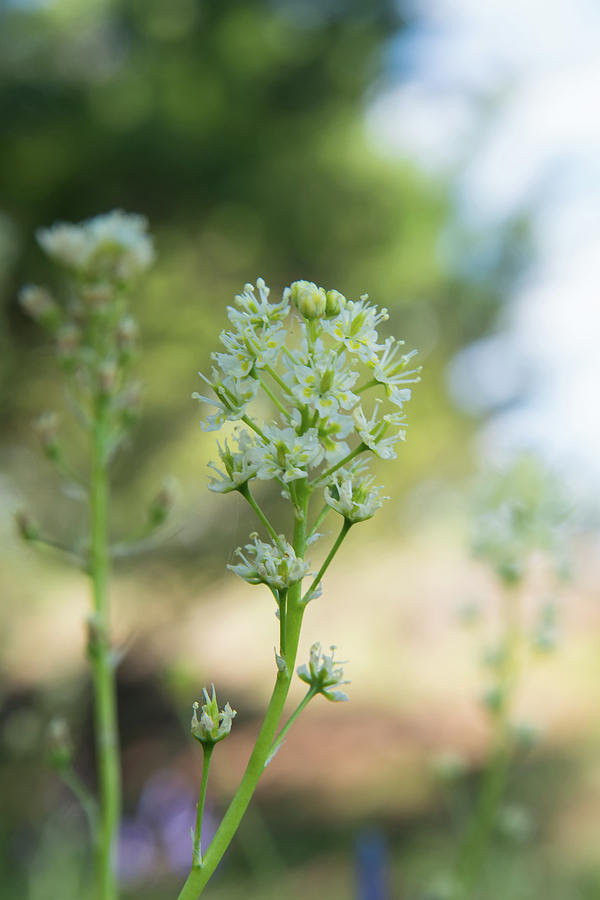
[227,533,310,591]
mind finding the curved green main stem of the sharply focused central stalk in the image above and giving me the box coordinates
[178,485,308,900]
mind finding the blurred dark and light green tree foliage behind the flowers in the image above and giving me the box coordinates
[0,0,524,540]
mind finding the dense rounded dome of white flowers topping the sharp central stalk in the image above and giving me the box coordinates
[194,279,419,491]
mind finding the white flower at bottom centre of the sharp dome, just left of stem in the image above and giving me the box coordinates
[255,425,323,482]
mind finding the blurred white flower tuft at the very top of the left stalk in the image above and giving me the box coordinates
[37,209,154,281]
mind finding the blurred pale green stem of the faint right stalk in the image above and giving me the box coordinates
[455,588,521,900]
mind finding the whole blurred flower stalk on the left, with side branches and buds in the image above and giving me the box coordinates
[19,211,158,900]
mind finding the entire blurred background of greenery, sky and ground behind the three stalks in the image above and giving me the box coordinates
[0,0,600,900]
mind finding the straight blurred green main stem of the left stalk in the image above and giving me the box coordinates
[90,399,121,900]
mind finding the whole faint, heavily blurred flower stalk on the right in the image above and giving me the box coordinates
[454,456,567,900]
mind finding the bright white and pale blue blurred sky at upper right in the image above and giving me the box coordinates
[368,0,600,490]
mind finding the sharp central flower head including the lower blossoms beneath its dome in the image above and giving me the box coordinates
[200,278,419,613]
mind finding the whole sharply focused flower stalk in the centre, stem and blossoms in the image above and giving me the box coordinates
[179,279,419,900]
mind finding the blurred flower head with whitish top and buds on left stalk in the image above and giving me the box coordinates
[20,210,154,431]
